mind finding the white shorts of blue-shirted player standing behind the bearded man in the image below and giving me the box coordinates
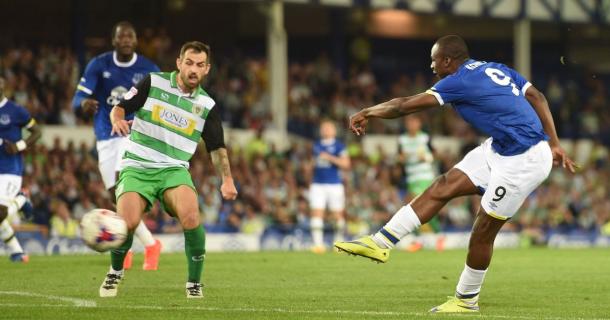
[96,137,129,189]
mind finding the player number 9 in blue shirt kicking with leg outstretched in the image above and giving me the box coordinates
[335,36,575,313]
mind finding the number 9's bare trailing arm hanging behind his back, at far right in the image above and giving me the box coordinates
[525,86,578,173]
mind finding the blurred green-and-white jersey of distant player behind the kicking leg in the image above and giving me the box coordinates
[398,131,436,183]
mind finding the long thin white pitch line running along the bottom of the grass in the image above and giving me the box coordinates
[0,302,610,320]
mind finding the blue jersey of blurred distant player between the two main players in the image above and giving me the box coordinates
[313,139,347,184]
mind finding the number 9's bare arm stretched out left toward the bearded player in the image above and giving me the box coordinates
[349,93,439,136]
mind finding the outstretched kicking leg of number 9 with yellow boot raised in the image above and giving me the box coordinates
[335,141,491,262]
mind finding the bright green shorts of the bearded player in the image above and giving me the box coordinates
[115,167,197,215]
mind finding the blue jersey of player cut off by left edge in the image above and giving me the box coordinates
[0,98,35,176]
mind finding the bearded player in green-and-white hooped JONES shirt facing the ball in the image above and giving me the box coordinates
[100,41,237,298]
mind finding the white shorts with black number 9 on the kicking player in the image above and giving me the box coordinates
[455,138,553,220]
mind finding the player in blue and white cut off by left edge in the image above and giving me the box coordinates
[0,77,41,262]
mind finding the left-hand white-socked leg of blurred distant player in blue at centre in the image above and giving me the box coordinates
[309,183,327,253]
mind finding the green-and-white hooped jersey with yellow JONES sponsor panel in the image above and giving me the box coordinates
[119,72,224,169]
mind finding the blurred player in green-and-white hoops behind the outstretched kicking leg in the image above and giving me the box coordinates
[398,115,444,252]
